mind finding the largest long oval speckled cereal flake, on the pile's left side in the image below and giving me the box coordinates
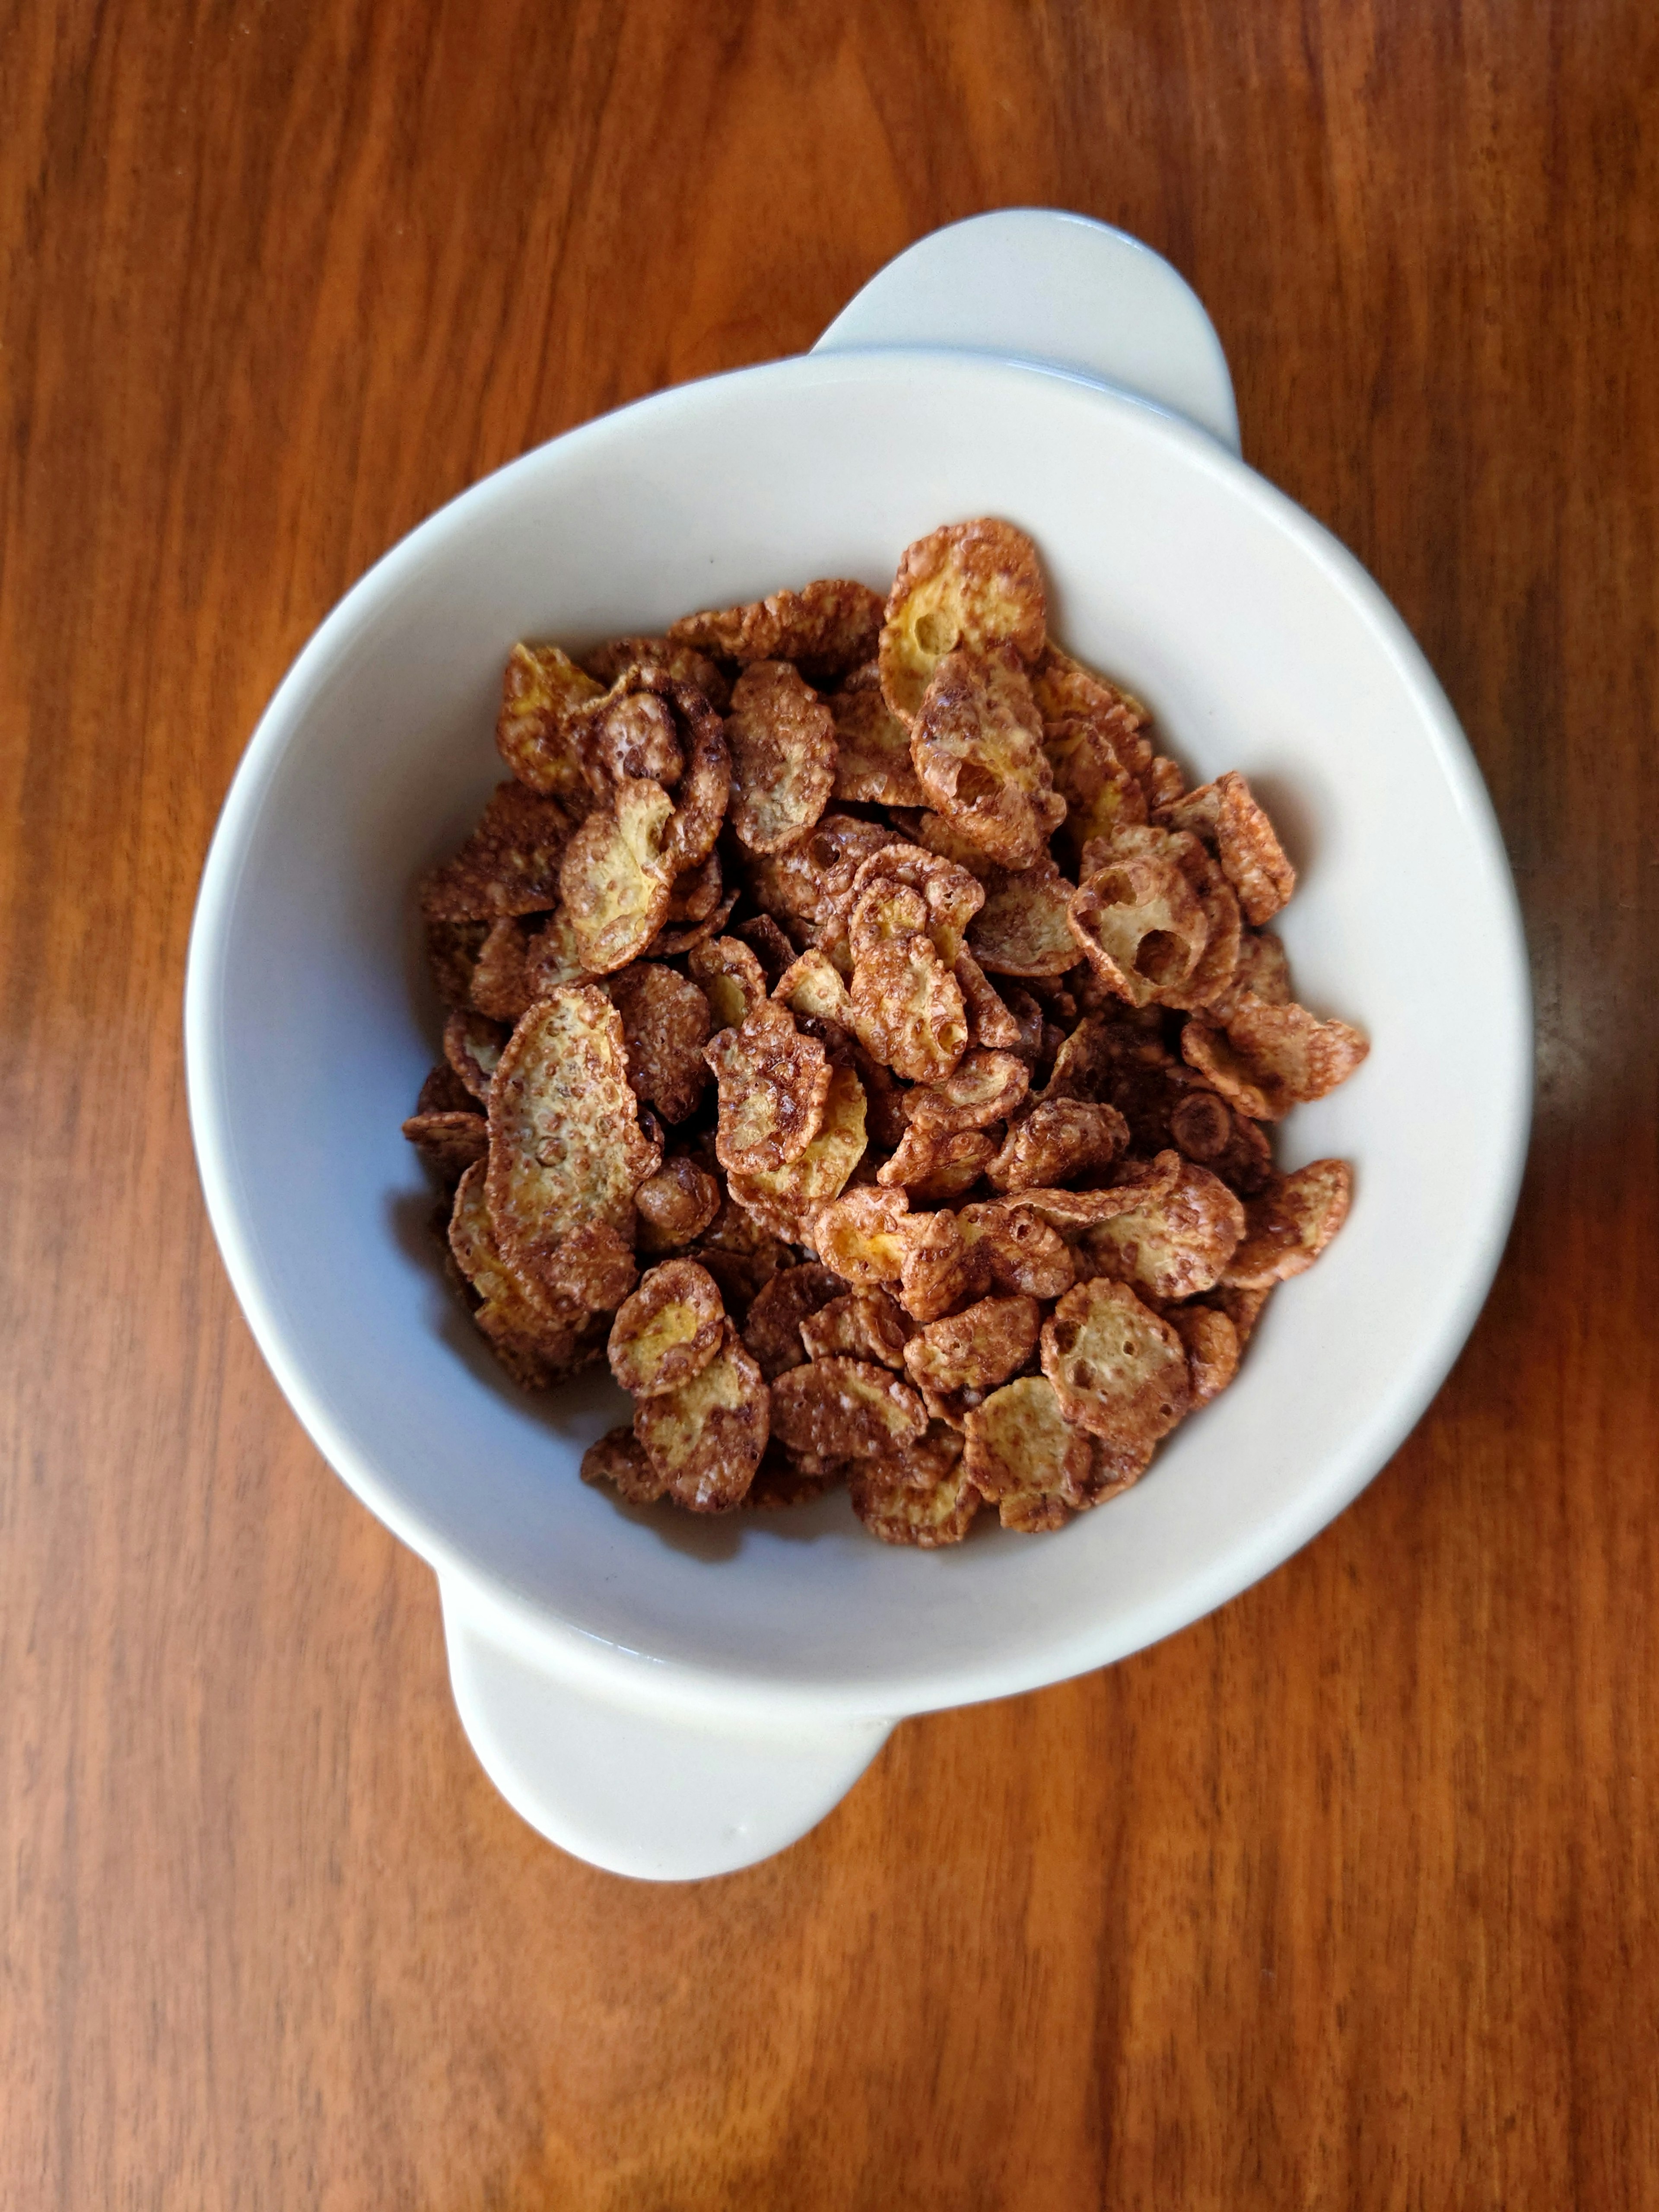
[489,984,661,1290]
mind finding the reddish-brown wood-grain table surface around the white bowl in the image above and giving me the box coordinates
[0,0,1659,2212]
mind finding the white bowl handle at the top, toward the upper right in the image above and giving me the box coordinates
[812,208,1239,454]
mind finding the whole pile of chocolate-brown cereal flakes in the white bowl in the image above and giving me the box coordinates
[405,520,1365,1546]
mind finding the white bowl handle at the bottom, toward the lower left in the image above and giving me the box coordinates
[438,1575,893,1882]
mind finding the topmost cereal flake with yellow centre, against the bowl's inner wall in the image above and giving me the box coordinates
[878,515,1049,721]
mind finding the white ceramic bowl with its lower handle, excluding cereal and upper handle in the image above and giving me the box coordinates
[188,216,1531,1876]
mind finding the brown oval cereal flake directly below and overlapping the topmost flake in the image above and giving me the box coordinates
[909,648,1066,867]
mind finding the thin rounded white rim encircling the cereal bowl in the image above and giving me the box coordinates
[184,345,1533,1721]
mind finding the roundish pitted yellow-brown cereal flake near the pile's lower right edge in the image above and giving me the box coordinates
[1042,1278,1192,1451]
